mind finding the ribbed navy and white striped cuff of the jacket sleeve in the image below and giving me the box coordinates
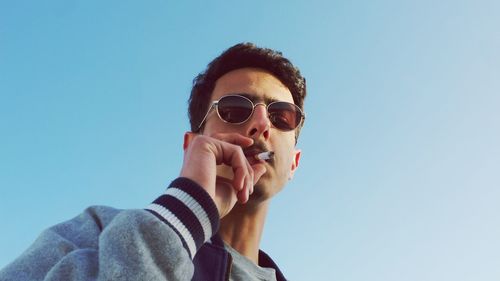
[146,178,219,258]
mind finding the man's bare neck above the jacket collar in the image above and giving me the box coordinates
[219,201,269,264]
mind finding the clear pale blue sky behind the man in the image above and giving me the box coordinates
[0,0,500,281]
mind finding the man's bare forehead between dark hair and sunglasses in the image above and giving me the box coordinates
[212,68,293,103]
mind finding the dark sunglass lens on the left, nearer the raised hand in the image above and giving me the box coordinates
[217,96,253,123]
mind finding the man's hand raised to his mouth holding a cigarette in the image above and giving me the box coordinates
[180,132,266,218]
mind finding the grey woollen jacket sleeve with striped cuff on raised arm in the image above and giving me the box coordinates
[0,178,219,281]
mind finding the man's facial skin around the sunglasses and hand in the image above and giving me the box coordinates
[203,68,300,200]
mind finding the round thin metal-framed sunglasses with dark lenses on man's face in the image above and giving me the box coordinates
[198,95,305,131]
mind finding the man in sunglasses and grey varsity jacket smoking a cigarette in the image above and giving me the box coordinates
[0,43,306,280]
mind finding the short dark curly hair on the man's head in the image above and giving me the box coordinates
[189,43,306,141]
